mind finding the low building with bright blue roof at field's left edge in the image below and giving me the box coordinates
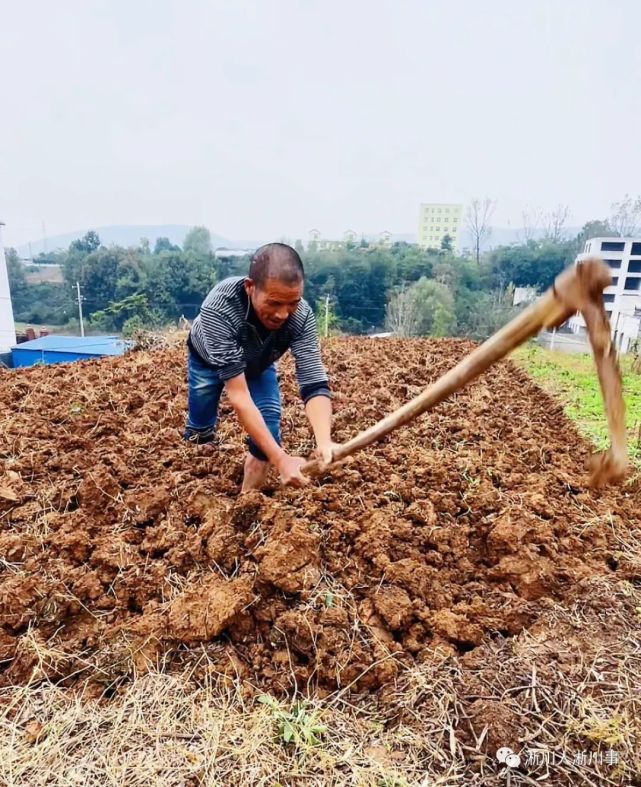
[11,335,128,367]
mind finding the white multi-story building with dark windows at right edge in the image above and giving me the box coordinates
[569,238,641,353]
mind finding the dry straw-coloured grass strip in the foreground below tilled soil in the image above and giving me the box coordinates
[0,579,641,787]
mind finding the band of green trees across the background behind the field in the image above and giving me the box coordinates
[6,214,617,338]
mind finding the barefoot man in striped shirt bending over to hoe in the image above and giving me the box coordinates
[184,243,334,492]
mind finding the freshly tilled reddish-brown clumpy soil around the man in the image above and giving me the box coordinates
[0,339,641,693]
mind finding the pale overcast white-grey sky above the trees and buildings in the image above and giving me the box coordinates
[0,0,641,245]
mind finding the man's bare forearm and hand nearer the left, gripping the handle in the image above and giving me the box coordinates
[225,374,309,486]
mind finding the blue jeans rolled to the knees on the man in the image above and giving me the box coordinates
[183,351,280,462]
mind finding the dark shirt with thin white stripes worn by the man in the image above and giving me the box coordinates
[187,276,330,402]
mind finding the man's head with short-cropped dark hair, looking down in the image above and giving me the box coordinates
[245,243,304,331]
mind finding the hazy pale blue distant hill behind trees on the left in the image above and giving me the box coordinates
[17,224,234,257]
